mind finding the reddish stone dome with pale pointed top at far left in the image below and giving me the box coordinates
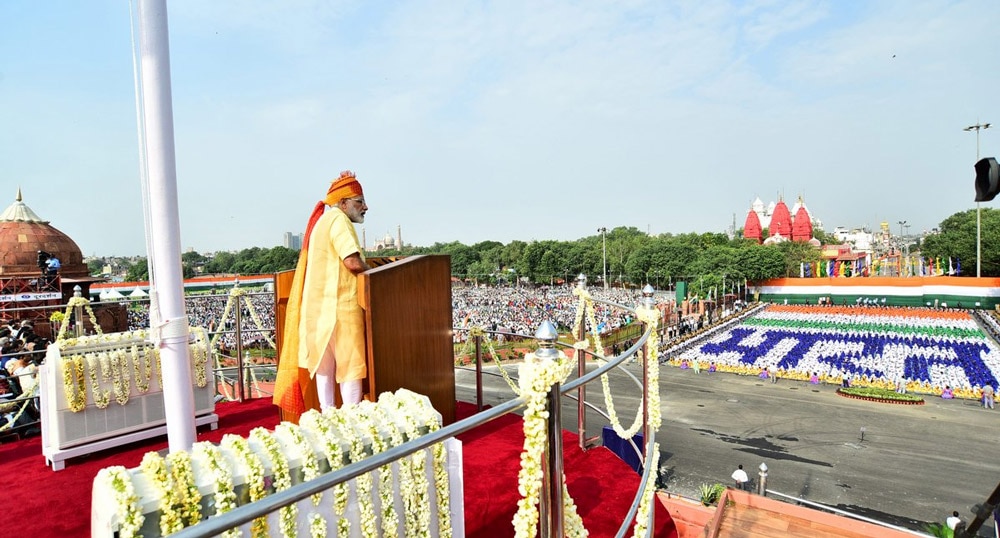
[0,189,90,278]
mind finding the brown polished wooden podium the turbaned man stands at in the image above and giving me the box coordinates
[275,255,455,424]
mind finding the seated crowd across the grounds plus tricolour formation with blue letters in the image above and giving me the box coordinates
[7,286,1000,404]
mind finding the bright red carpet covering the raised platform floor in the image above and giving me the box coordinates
[0,399,676,538]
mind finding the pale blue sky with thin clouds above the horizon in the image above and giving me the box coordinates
[0,0,1000,255]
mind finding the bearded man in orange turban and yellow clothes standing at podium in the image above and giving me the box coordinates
[274,170,369,421]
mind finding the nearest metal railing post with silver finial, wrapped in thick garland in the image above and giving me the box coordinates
[535,320,564,538]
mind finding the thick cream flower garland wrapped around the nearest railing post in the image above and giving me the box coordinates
[513,352,587,538]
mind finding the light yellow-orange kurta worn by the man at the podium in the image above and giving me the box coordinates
[298,207,367,383]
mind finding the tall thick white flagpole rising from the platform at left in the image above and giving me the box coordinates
[138,0,197,452]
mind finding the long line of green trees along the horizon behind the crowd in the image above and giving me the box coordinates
[97,208,1000,294]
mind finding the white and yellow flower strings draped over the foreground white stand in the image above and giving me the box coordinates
[95,389,452,538]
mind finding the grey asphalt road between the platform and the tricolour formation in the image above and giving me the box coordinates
[456,364,1000,536]
